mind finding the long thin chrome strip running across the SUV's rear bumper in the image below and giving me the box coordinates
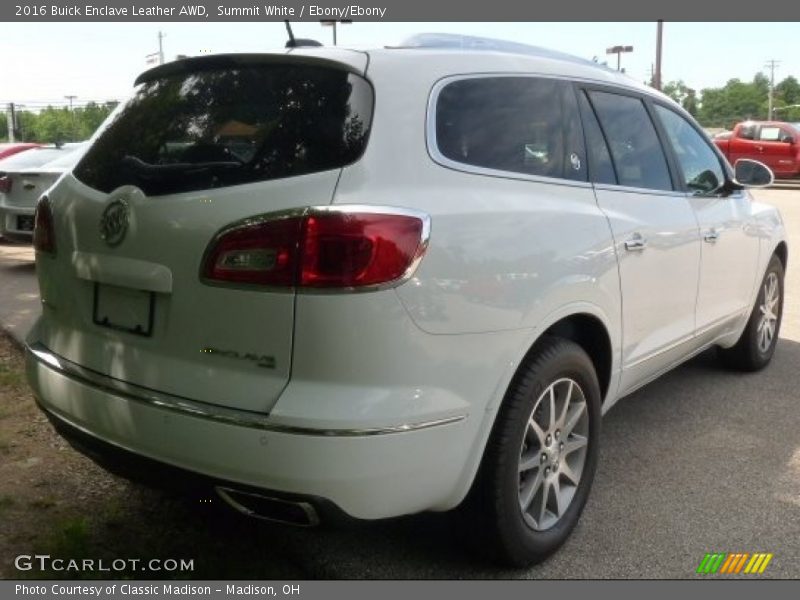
[26,343,467,437]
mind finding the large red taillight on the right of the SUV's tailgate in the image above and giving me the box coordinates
[202,207,430,289]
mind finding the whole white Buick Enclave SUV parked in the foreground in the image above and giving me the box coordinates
[28,37,787,564]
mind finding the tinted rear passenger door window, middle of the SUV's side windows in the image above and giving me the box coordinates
[590,92,672,190]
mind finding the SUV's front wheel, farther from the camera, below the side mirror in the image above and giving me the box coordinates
[719,254,784,371]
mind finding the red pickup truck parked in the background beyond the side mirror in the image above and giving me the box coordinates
[714,121,800,177]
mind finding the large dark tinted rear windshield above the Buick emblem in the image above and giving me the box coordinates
[75,64,373,196]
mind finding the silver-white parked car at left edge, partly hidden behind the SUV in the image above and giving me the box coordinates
[0,142,86,242]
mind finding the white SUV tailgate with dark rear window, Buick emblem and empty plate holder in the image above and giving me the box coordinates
[32,57,372,412]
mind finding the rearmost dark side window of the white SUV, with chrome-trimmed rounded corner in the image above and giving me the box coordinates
[436,77,586,180]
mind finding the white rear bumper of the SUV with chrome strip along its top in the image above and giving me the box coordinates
[26,345,472,519]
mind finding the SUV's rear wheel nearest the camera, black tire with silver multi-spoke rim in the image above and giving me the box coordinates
[471,337,601,566]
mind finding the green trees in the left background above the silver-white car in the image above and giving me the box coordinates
[0,102,118,144]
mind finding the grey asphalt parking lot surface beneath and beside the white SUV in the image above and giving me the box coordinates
[0,189,800,579]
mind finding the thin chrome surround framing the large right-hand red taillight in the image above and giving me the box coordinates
[199,204,431,295]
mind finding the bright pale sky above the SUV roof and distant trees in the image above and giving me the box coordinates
[0,21,800,105]
